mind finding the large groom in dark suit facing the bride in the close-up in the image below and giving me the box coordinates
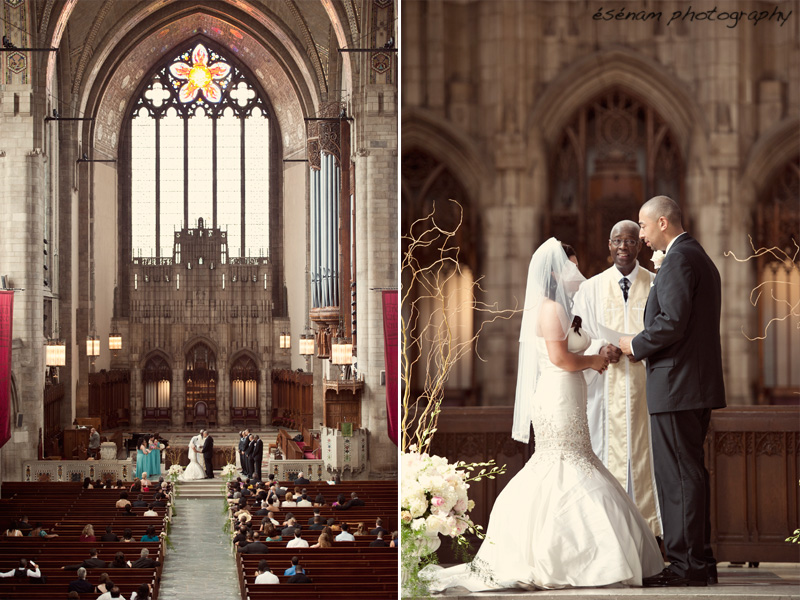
[620,196,725,587]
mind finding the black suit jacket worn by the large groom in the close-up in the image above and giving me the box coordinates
[631,233,725,414]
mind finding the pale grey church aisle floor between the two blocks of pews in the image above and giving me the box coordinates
[158,494,241,600]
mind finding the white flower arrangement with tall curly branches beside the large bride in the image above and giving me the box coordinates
[400,200,517,598]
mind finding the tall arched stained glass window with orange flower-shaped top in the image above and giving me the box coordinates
[130,43,275,260]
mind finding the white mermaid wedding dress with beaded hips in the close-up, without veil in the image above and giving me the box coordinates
[421,329,664,591]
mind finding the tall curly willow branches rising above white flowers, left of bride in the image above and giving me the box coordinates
[400,200,519,453]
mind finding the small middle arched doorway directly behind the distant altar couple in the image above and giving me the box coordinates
[184,342,218,427]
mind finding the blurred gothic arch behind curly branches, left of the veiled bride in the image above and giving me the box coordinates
[401,149,480,406]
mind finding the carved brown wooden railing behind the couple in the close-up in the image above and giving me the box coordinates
[432,406,800,563]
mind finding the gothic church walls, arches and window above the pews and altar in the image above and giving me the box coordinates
[0,0,398,480]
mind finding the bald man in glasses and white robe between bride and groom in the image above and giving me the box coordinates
[573,221,662,536]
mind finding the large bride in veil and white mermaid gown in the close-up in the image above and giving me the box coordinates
[421,238,664,591]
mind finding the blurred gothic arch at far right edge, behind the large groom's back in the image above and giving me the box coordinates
[750,156,800,404]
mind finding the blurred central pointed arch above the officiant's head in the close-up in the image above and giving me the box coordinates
[542,88,688,277]
